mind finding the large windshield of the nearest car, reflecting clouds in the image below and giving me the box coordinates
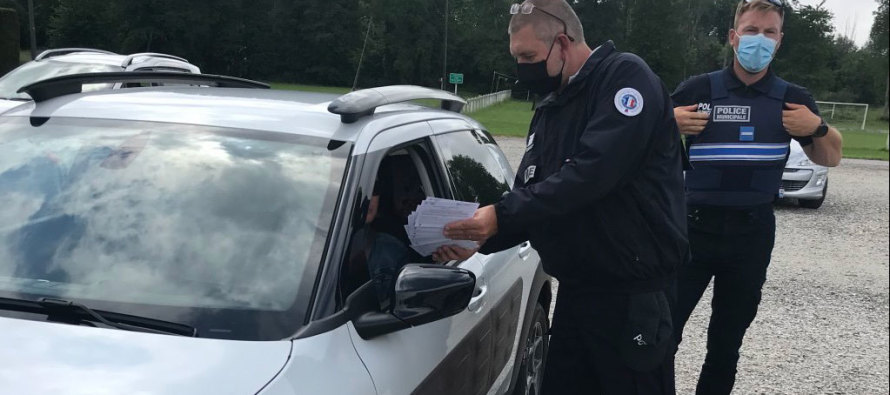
[0,117,351,340]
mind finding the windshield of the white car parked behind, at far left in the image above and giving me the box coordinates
[0,60,122,100]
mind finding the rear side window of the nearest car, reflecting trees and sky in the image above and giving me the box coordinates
[436,130,510,206]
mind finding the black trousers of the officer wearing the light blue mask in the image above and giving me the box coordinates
[674,205,776,395]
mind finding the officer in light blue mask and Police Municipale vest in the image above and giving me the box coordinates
[673,0,841,394]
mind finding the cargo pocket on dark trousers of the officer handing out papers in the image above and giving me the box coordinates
[618,291,674,372]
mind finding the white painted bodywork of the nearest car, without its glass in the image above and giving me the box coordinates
[0,87,550,395]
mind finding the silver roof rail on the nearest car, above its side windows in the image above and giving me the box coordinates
[328,85,467,123]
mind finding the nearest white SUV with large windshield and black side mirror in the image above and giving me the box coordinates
[0,73,551,395]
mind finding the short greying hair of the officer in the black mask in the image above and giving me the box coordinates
[508,0,584,43]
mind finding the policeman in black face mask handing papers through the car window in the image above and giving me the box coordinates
[439,0,688,395]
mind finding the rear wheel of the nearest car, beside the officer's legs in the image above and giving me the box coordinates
[513,302,550,395]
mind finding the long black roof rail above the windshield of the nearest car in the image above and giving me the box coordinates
[18,71,269,103]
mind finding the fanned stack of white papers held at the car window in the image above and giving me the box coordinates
[405,197,479,256]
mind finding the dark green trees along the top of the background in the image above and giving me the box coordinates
[0,0,888,112]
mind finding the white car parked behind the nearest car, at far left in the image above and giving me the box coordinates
[0,48,201,112]
